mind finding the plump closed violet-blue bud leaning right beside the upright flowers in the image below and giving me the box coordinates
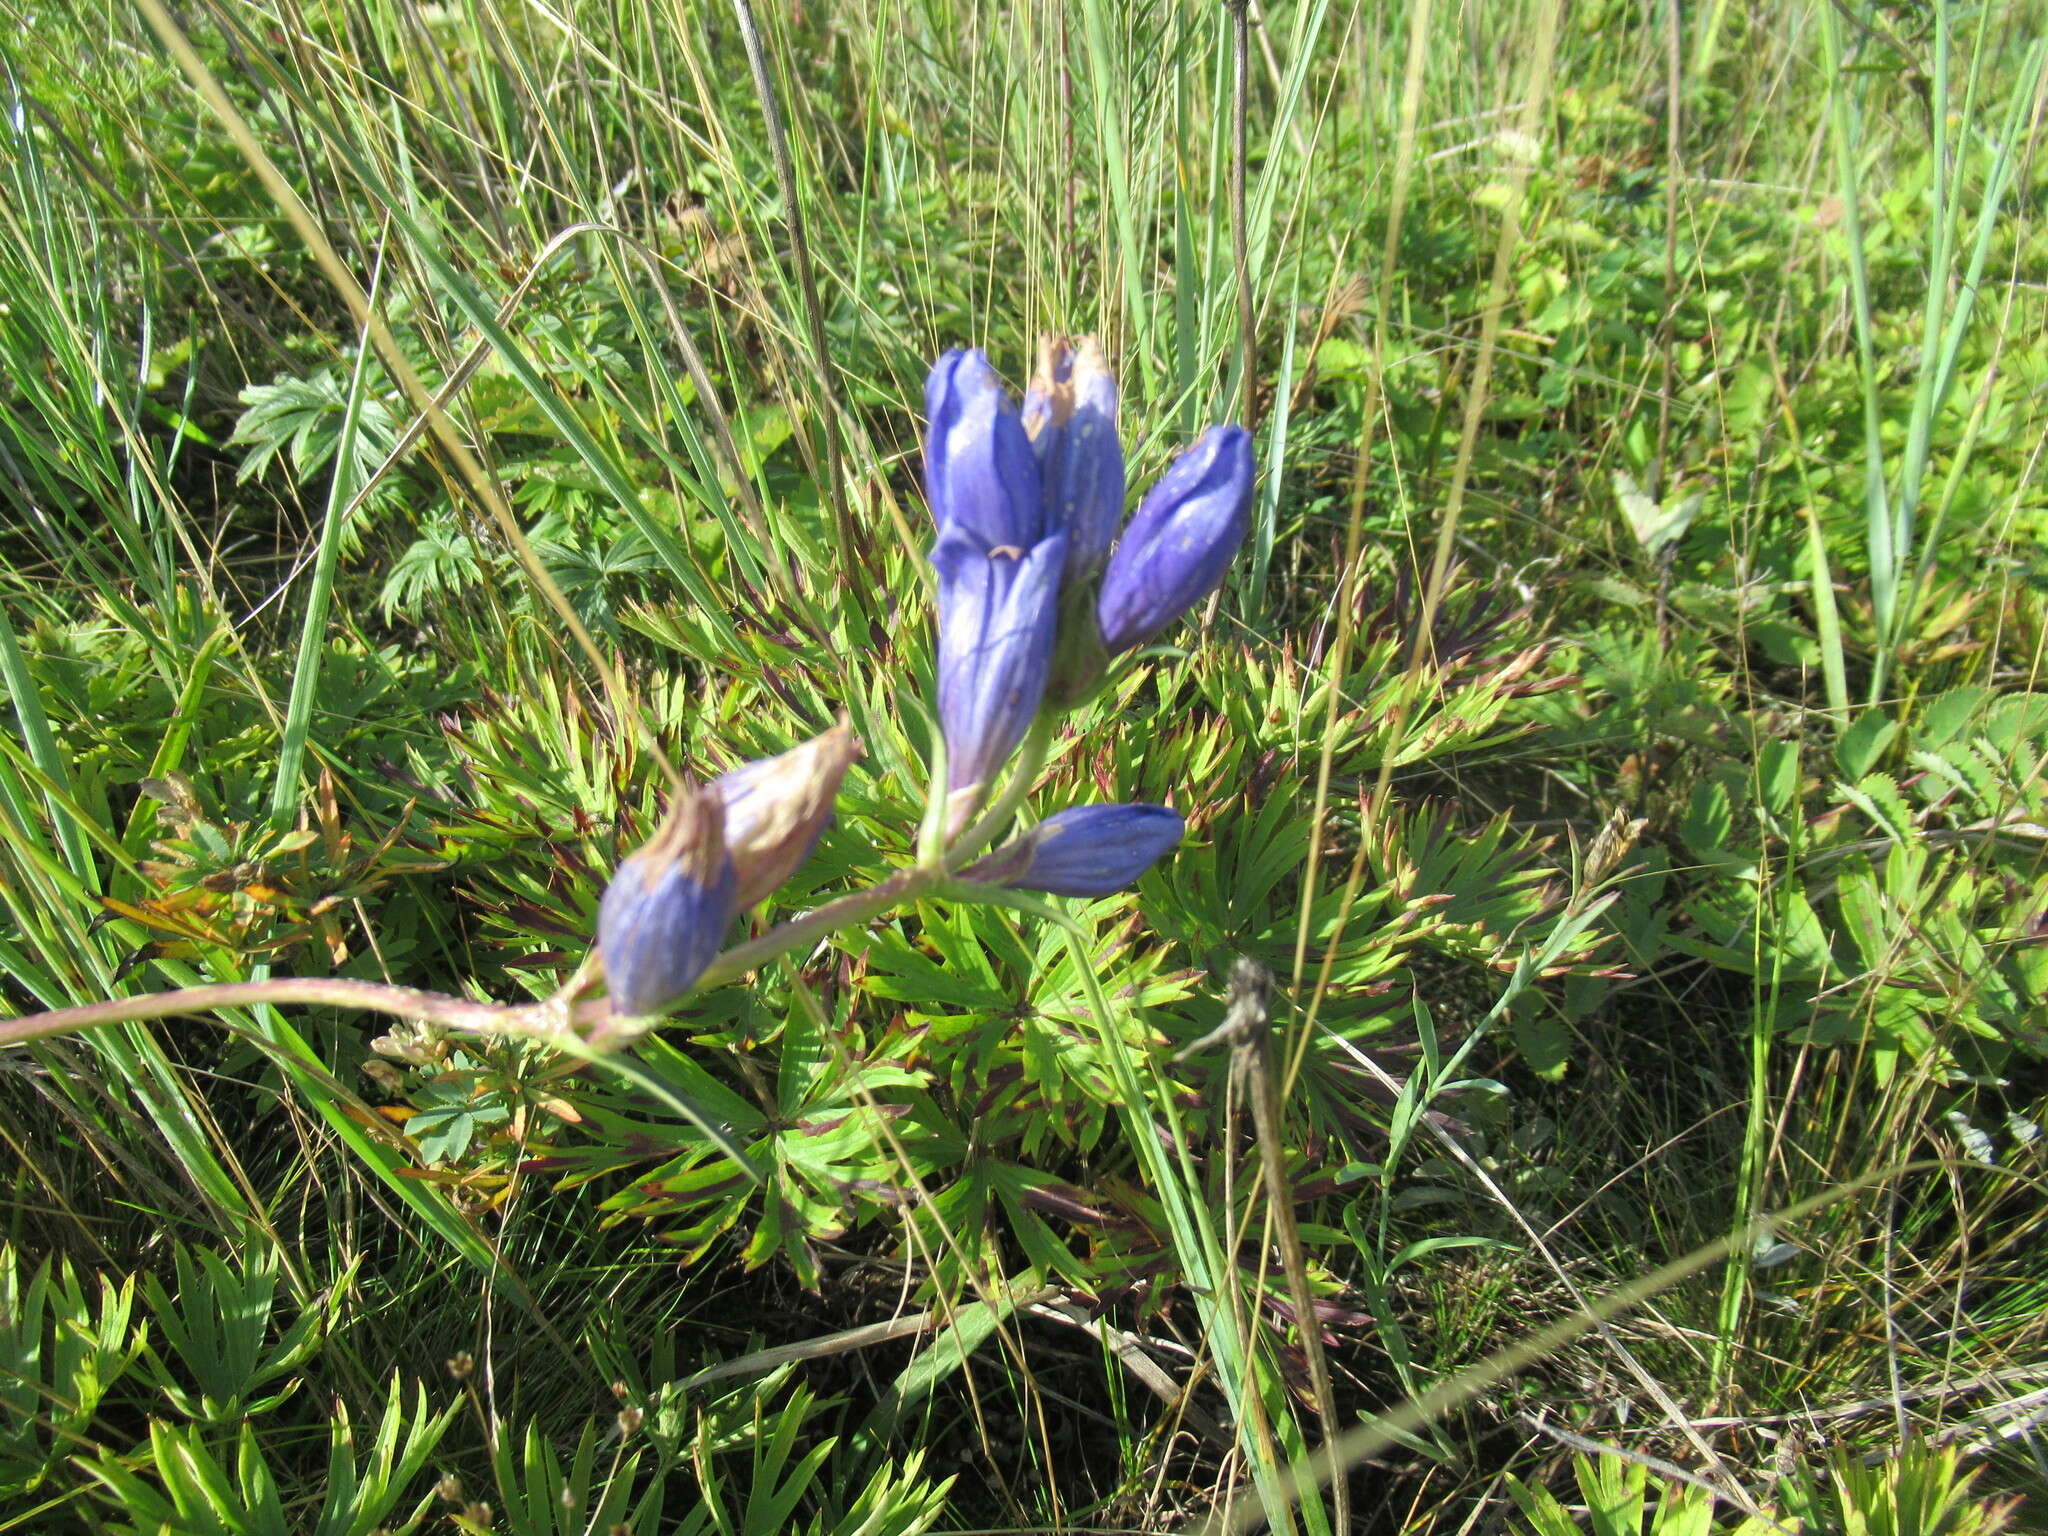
[1096,426,1253,653]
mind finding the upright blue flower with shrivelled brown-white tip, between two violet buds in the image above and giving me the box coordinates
[1022,336,1124,580]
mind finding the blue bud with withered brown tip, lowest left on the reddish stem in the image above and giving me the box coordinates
[598,788,739,1018]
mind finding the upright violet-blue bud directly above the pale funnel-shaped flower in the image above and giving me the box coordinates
[924,348,1044,549]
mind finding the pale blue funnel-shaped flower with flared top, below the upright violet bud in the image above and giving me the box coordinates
[932,522,1067,809]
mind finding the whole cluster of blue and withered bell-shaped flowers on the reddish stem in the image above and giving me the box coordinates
[598,340,1253,1018]
